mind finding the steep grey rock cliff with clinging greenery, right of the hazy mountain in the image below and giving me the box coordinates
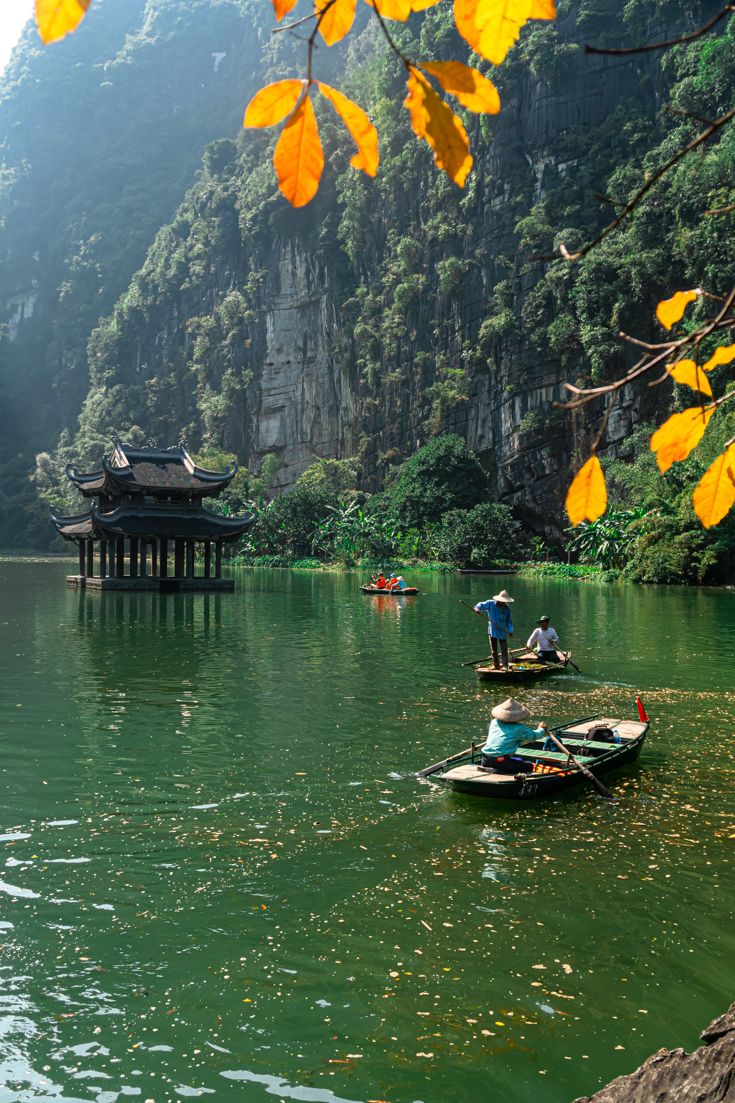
[2,0,719,538]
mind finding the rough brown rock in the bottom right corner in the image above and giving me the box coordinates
[574,1004,735,1103]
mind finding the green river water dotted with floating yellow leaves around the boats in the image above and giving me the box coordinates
[0,561,735,1103]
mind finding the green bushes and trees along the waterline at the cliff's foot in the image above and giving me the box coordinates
[32,430,735,586]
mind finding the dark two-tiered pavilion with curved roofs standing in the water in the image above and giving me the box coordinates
[51,440,255,592]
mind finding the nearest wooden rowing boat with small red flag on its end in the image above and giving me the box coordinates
[419,716,649,801]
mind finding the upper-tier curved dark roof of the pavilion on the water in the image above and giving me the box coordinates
[66,440,237,497]
